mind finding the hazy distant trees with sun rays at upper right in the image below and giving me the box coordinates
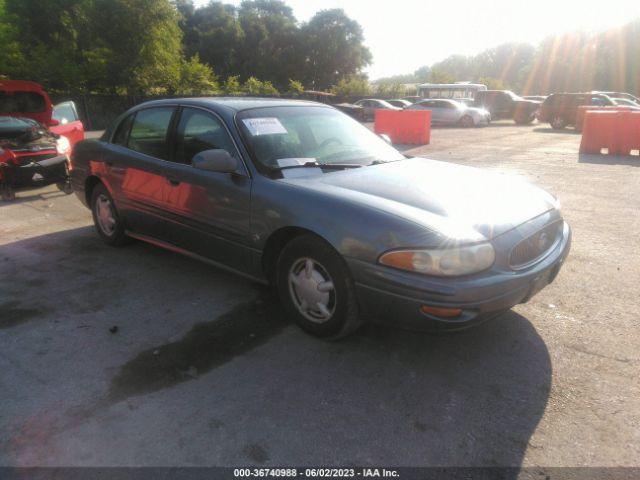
[374,20,640,94]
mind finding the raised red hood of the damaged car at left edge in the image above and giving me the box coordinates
[0,80,53,125]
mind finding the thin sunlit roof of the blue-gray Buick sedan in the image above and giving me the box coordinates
[137,97,328,112]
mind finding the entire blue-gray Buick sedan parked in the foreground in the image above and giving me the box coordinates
[71,98,571,337]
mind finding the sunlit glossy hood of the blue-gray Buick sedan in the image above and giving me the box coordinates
[281,158,556,241]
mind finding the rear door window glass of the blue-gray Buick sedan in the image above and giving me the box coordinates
[127,107,175,160]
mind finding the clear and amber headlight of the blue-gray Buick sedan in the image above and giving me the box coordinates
[378,243,496,277]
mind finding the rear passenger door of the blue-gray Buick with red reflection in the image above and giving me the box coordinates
[104,106,176,240]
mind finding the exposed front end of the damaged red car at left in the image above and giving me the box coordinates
[0,116,71,200]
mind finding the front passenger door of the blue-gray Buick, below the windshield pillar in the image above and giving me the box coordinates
[159,107,251,271]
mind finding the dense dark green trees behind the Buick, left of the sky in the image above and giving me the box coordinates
[0,0,371,95]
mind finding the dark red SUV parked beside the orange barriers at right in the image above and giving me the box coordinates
[537,93,615,130]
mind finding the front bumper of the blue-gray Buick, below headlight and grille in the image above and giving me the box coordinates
[347,223,571,331]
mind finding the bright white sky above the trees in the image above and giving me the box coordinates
[190,0,640,80]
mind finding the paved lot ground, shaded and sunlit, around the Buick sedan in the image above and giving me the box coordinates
[0,123,640,466]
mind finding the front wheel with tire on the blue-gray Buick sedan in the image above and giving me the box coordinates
[276,235,362,338]
